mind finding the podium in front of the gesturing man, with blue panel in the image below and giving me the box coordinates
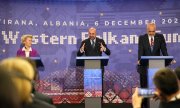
[76,56,109,108]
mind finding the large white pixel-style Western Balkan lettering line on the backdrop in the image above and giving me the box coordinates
[2,31,180,45]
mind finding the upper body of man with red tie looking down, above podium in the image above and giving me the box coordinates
[138,23,168,60]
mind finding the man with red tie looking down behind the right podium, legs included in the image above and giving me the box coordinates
[137,23,168,108]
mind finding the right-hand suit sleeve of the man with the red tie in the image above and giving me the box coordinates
[161,35,168,56]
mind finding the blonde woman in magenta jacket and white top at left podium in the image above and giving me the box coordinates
[17,34,39,57]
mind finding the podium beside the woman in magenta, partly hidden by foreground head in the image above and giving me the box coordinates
[30,57,44,71]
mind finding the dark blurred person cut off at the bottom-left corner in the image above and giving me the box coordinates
[0,66,21,108]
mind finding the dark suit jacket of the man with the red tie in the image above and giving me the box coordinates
[138,33,168,60]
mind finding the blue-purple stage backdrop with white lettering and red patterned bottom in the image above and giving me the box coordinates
[0,0,180,103]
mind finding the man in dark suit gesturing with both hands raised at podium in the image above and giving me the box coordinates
[77,27,111,56]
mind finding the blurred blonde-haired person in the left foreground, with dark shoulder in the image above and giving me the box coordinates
[0,57,55,108]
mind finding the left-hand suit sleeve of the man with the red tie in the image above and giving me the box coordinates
[138,36,144,60]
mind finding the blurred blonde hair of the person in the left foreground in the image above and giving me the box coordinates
[0,57,34,103]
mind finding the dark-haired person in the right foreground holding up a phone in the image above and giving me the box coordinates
[132,68,180,108]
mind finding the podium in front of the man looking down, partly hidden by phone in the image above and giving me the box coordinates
[140,56,174,108]
